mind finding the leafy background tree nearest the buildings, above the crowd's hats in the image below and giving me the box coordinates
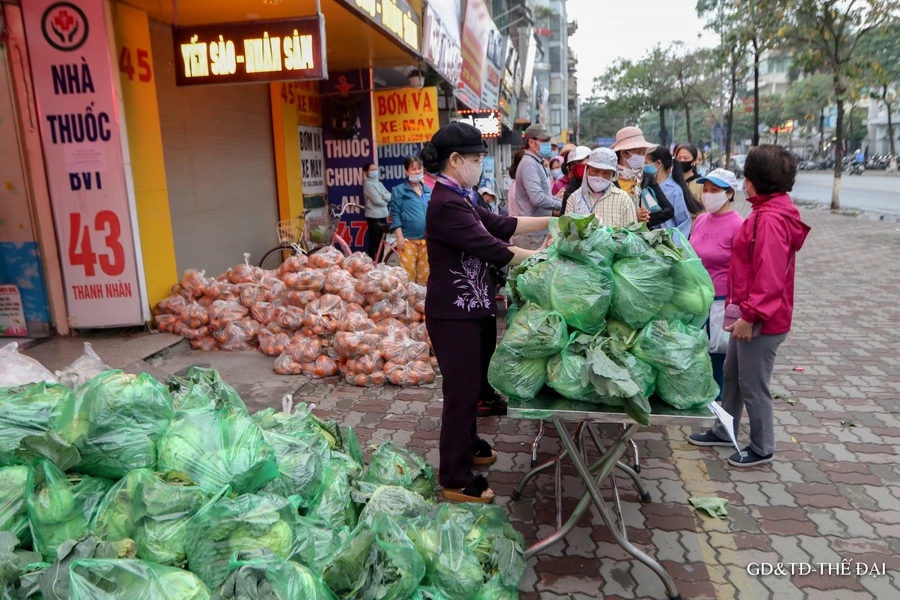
[594,45,678,146]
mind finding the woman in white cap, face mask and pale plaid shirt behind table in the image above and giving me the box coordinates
[565,148,637,227]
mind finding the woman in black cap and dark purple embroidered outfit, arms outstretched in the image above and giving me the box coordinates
[419,122,550,502]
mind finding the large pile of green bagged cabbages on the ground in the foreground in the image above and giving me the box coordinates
[0,364,528,600]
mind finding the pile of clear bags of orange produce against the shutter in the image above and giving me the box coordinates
[154,248,437,386]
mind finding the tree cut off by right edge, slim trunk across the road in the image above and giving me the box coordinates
[859,21,900,171]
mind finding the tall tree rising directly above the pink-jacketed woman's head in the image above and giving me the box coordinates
[697,0,785,146]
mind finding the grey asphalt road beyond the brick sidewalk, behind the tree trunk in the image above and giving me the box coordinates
[791,172,900,215]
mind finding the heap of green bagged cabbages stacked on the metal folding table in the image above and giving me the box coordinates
[488,215,718,425]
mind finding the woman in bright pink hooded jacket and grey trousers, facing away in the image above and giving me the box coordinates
[688,144,810,467]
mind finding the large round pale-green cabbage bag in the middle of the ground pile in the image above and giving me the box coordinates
[159,400,279,494]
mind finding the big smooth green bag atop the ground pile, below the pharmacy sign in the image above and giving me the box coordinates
[75,371,175,479]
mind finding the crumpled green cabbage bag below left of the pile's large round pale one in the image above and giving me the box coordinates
[91,469,209,567]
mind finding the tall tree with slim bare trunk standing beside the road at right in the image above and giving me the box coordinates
[785,0,900,210]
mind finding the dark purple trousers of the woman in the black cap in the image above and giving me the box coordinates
[425,317,497,489]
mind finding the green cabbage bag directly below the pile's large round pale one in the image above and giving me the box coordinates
[185,488,296,588]
